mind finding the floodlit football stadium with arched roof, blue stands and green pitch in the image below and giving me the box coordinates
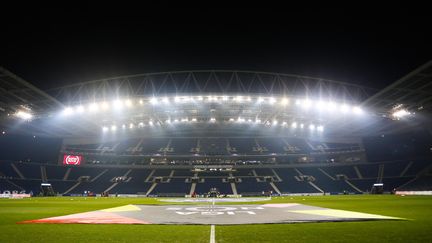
[0,61,432,242]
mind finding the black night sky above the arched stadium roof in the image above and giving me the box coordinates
[0,7,432,89]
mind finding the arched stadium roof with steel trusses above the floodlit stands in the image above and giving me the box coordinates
[0,61,432,137]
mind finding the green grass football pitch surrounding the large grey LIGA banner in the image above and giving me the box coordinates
[0,195,432,242]
